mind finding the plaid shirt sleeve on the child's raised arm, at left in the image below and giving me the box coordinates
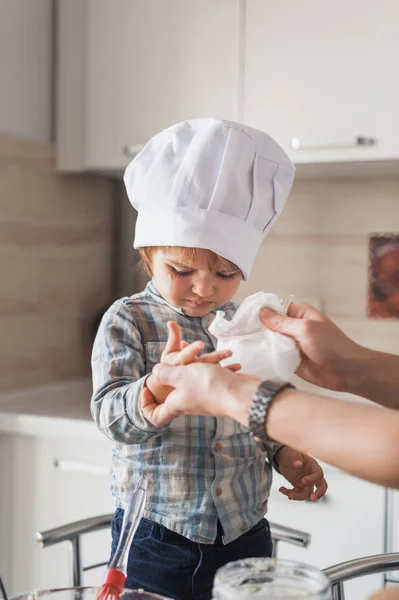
[90,299,168,444]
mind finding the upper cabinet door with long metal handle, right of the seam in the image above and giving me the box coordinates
[244,0,399,163]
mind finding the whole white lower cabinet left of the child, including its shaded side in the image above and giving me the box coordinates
[0,418,114,595]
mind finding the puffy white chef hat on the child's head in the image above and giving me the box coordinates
[124,119,295,279]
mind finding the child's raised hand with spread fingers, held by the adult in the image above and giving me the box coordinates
[142,321,240,422]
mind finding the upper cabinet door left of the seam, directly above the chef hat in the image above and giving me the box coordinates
[85,0,240,169]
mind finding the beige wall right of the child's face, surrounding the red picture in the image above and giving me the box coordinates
[239,178,399,353]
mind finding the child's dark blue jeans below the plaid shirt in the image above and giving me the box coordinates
[111,508,272,600]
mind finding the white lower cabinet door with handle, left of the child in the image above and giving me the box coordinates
[30,433,114,589]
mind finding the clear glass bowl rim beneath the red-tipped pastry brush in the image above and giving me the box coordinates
[10,587,171,600]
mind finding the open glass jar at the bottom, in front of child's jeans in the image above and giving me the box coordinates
[212,558,331,600]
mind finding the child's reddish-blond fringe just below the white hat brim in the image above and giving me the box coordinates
[138,246,238,275]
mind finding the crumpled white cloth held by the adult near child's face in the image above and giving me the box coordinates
[209,292,300,381]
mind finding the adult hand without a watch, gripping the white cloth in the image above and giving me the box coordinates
[260,303,366,391]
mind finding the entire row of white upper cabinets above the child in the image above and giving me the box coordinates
[56,0,399,174]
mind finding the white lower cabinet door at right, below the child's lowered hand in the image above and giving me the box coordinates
[267,467,384,600]
